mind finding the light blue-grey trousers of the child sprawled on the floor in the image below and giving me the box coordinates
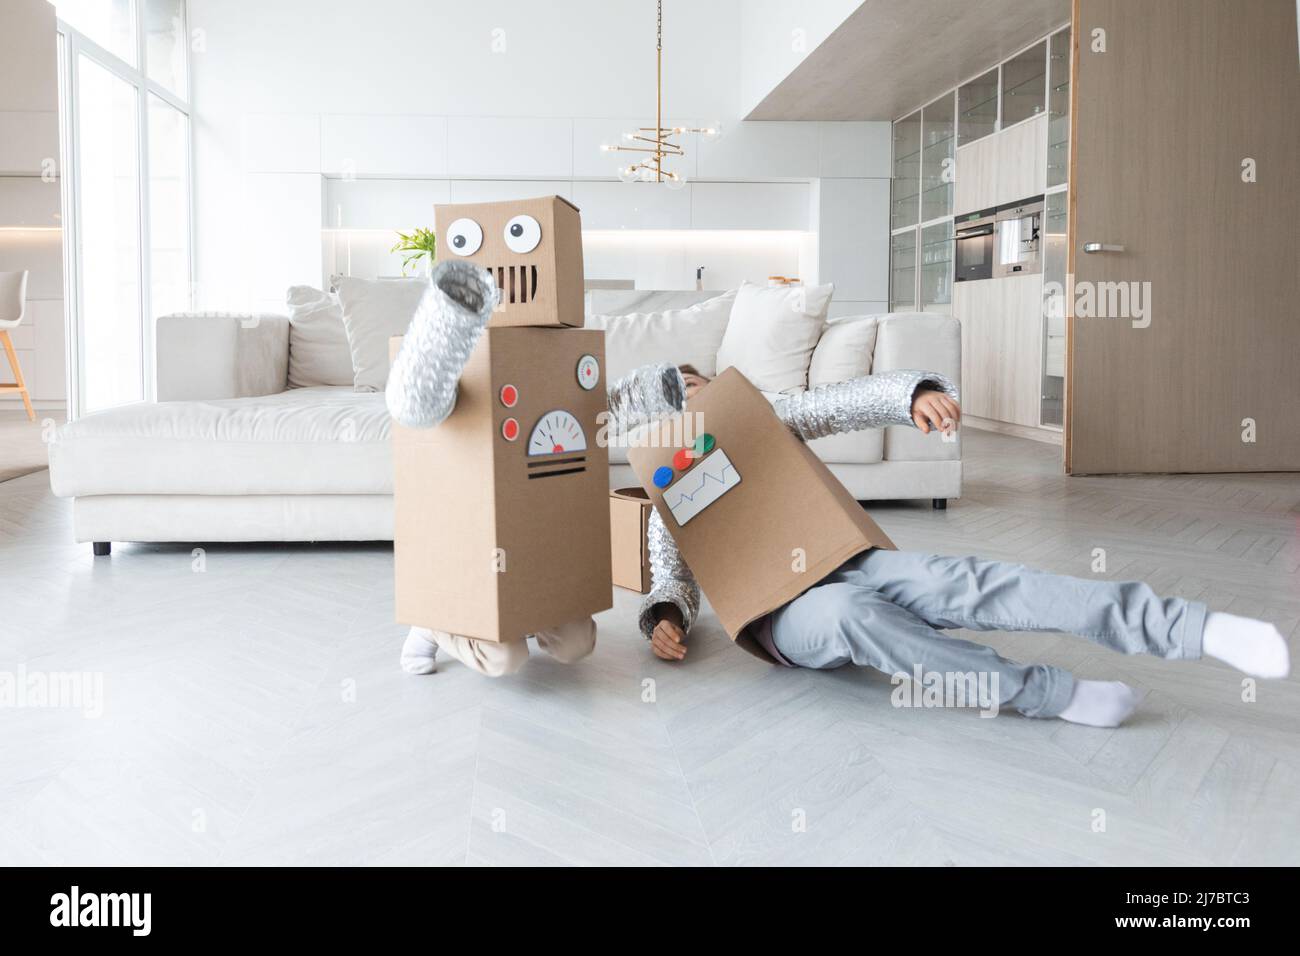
[771,549,1205,717]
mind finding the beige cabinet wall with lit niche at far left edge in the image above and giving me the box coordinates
[0,0,65,408]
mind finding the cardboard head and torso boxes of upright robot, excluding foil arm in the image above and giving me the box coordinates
[391,196,612,643]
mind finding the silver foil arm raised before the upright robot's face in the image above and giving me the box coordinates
[384,261,499,428]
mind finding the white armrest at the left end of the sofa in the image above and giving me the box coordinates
[153,312,289,402]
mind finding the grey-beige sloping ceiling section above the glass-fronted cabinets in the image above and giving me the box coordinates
[745,0,1070,120]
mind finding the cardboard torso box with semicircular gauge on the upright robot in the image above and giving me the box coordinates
[393,326,612,643]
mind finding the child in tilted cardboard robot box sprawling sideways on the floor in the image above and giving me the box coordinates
[628,369,1290,726]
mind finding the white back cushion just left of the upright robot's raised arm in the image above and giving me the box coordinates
[337,276,429,392]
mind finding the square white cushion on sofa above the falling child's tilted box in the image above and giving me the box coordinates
[718,282,835,392]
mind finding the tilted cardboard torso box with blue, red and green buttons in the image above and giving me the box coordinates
[628,368,893,649]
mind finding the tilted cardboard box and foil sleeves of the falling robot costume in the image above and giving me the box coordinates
[628,368,957,659]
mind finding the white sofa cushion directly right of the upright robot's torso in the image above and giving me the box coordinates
[586,291,736,382]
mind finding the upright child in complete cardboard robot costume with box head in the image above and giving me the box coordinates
[386,196,611,676]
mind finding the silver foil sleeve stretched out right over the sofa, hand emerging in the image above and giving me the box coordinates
[775,368,957,441]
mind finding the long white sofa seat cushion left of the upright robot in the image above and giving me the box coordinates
[49,388,393,497]
